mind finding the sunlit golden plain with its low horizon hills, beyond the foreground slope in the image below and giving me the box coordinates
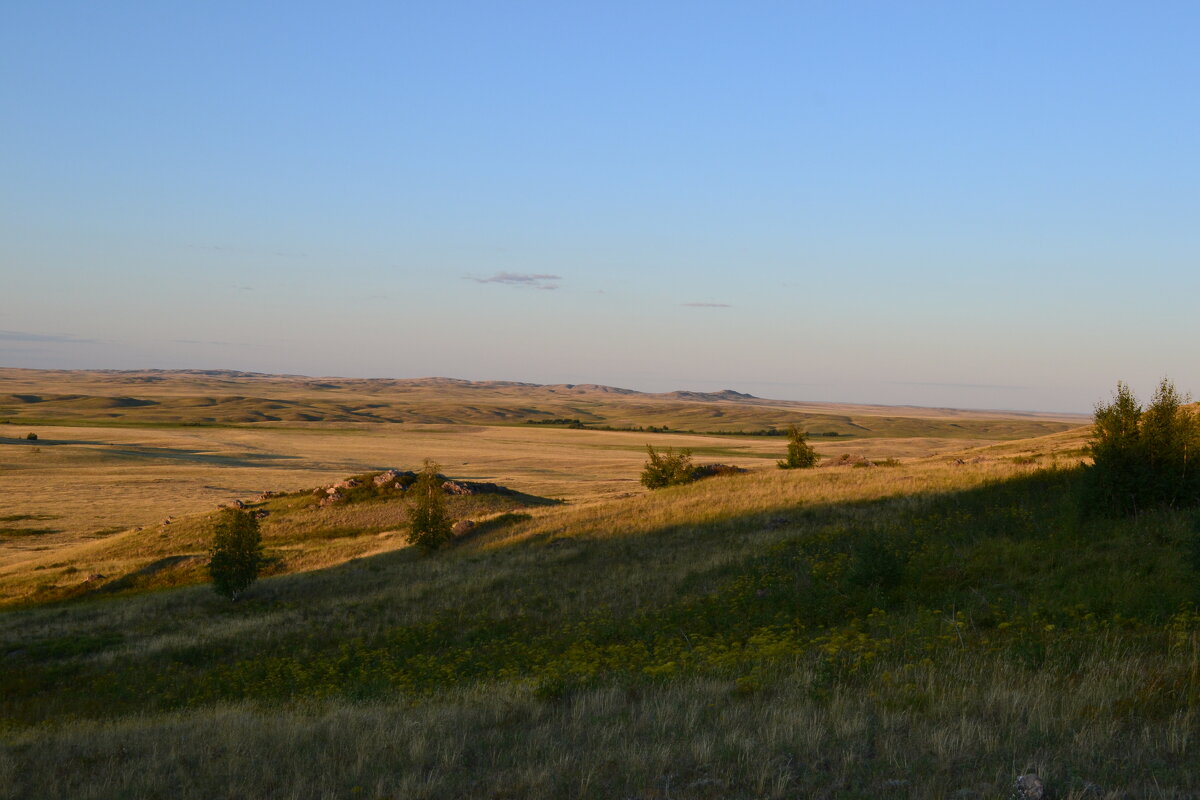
[0,369,1076,602]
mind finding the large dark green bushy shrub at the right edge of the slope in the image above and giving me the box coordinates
[1084,379,1200,515]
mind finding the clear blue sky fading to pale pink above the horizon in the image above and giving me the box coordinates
[0,0,1200,413]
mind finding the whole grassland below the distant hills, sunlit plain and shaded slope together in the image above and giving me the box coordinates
[0,371,1200,800]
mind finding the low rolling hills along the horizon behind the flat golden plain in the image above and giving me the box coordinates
[0,368,1087,439]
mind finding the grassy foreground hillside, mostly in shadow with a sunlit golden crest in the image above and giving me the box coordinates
[0,441,1200,798]
